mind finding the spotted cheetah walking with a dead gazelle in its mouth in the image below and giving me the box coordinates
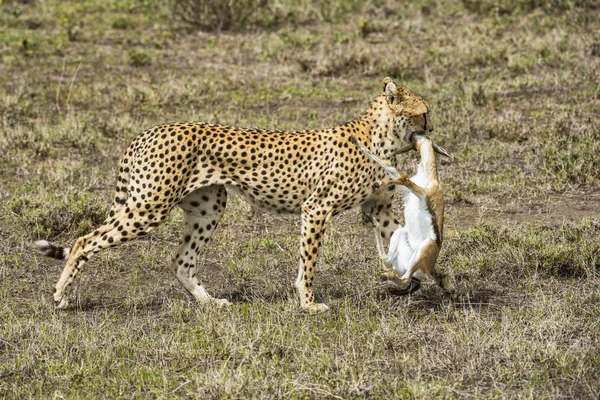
[36,77,433,313]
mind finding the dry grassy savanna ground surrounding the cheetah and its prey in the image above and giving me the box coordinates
[0,0,600,399]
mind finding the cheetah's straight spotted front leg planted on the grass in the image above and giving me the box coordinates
[295,207,329,314]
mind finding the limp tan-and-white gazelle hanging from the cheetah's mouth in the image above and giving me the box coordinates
[355,134,454,293]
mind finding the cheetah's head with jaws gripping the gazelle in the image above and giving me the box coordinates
[383,77,433,143]
